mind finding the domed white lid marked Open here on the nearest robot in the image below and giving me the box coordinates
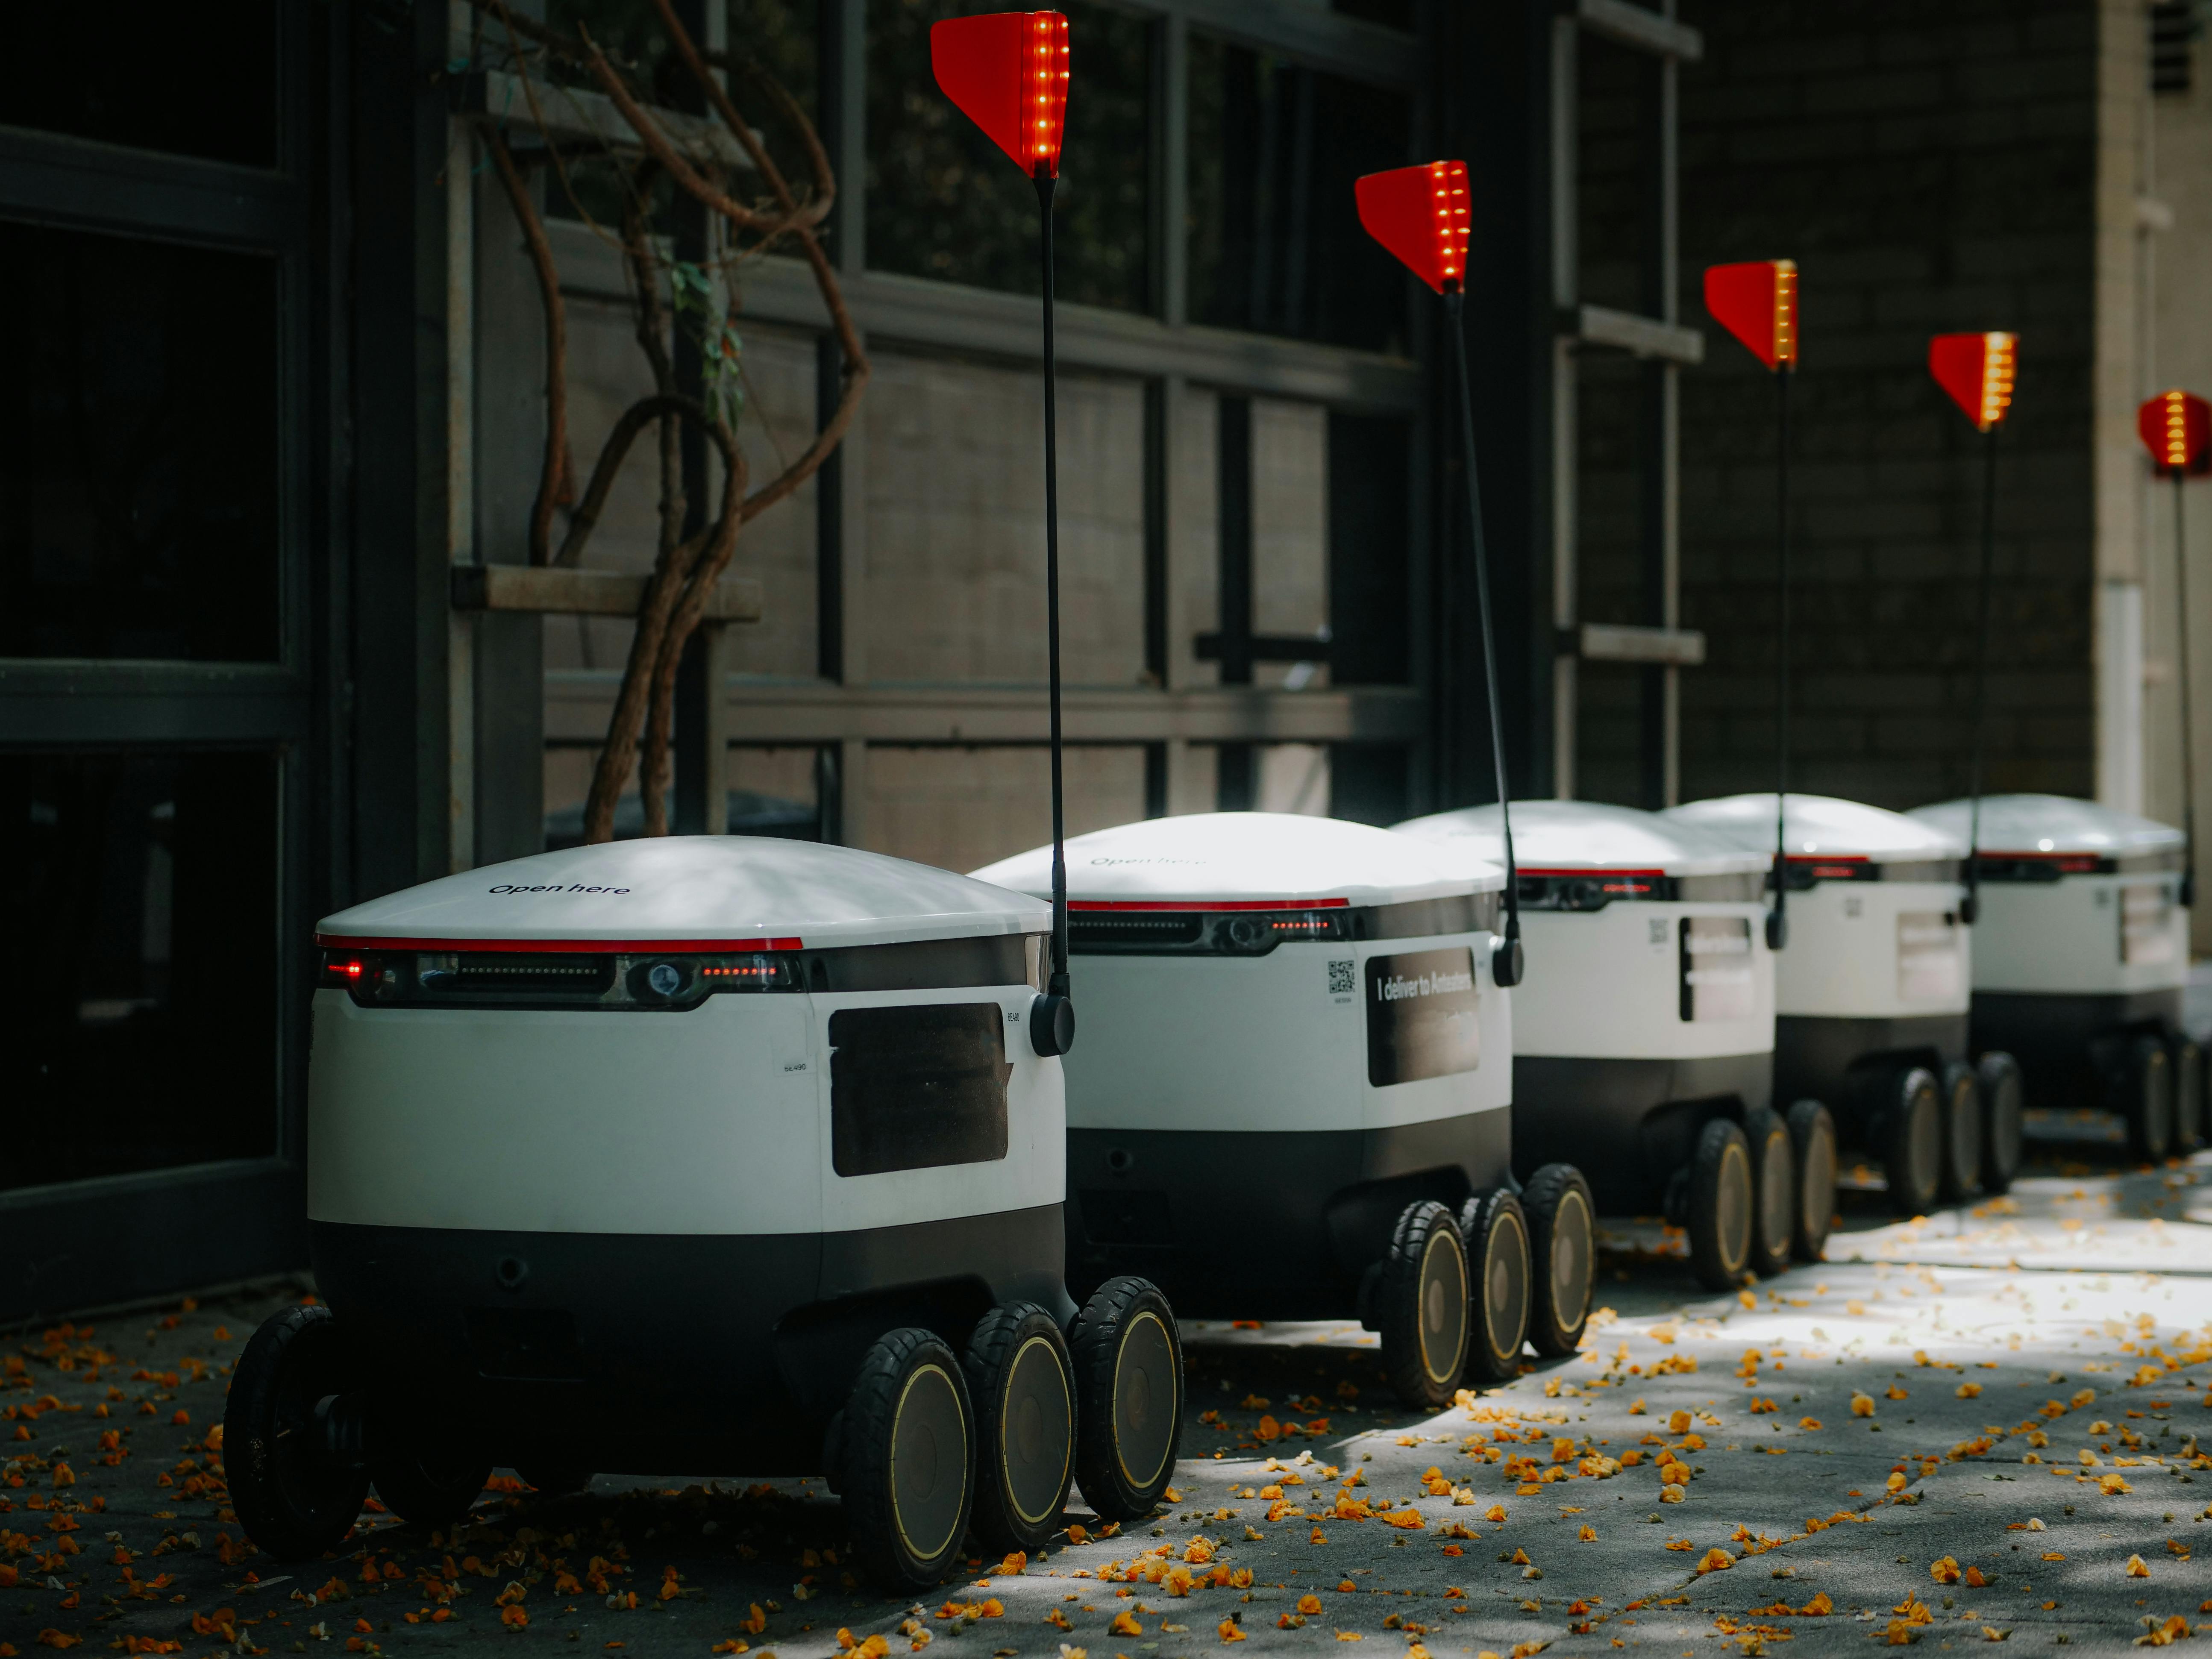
[316,836,1053,951]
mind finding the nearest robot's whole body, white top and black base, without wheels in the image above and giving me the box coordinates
[308,836,1073,1473]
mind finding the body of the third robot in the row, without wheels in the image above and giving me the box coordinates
[1398,801,1774,1212]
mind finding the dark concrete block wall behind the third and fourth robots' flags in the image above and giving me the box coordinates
[1582,0,2099,807]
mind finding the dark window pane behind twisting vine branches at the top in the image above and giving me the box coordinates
[535,0,816,230]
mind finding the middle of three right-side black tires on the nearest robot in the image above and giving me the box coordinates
[966,1303,1075,1553]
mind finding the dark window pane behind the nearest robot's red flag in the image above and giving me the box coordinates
[867,0,1152,312]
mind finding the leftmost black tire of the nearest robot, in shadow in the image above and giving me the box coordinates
[223,1307,370,1562]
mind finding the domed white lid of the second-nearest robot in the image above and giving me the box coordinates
[975,812,1507,909]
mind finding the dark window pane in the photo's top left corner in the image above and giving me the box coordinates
[0,0,276,166]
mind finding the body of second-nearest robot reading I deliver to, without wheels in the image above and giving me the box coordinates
[975,812,1513,1318]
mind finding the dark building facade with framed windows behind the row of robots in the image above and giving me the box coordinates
[0,0,2212,1318]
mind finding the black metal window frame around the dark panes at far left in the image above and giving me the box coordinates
[0,4,327,1314]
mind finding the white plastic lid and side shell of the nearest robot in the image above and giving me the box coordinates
[308,836,1066,1234]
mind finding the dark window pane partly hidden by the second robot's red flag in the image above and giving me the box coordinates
[1190,35,1411,354]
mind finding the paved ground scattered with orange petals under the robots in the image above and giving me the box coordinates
[13,1159,2212,1659]
